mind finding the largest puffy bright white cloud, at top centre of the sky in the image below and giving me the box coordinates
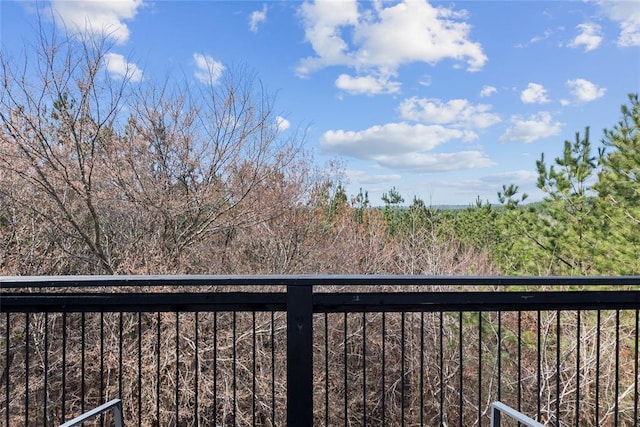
[297,0,487,76]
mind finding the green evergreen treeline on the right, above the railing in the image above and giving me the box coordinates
[364,94,640,275]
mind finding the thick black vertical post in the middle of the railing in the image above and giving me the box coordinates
[287,284,313,427]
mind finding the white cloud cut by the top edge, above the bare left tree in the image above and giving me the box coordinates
[51,0,144,44]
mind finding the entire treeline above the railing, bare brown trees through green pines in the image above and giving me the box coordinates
[0,33,640,275]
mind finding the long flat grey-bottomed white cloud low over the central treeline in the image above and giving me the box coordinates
[320,122,491,172]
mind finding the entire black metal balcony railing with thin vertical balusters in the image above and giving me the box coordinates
[0,276,640,426]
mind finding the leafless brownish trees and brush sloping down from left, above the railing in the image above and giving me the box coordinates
[0,30,496,275]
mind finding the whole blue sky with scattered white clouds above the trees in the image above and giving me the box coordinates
[0,0,640,205]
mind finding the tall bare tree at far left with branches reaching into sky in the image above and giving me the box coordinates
[0,28,127,273]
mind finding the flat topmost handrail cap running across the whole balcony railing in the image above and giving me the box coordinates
[0,274,640,289]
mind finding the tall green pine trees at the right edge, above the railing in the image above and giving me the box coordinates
[497,94,640,275]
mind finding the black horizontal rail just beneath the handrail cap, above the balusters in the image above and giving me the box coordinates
[0,286,640,313]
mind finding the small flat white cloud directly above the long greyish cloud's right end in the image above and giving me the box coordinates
[399,97,500,128]
